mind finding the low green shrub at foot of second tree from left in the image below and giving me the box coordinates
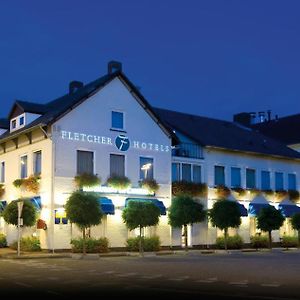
[71,237,108,253]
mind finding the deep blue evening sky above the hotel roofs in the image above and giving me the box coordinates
[0,0,300,120]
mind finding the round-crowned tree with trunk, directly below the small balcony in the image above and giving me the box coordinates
[168,195,206,251]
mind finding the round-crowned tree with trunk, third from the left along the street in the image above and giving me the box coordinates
[122,201,160,256]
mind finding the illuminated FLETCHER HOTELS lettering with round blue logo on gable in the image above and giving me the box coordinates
[60,130,170,152]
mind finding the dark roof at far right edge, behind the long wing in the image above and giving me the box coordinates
[252,114,300,145]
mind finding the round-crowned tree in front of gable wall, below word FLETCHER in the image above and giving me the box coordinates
[65,191,103,255]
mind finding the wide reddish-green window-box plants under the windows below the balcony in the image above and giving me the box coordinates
[172,181,207,197]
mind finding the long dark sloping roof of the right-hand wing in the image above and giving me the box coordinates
[154,108,300,158]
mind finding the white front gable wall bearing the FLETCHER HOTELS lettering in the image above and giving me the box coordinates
[49,78,171,248]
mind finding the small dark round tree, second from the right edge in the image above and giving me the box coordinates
[256,205,284,249]
